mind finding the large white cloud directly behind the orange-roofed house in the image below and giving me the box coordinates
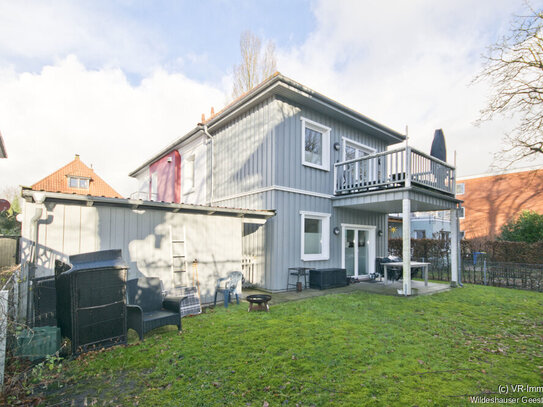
[0,56,225,195]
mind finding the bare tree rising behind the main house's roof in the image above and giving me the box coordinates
[232,31,277,99]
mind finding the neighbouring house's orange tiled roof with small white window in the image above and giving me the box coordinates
[32,154,122,198]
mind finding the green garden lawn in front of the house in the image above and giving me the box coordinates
[28,286,543,407]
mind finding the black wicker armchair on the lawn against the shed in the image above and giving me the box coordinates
[126,277,187,340]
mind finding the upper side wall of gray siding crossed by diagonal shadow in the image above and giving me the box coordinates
[212,98,279,199]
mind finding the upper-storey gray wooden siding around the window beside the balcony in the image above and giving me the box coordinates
[275,99,392,194]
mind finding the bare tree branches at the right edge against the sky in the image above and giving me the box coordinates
[474,6,543,167]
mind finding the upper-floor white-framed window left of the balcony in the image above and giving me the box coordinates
[302,117,331,171]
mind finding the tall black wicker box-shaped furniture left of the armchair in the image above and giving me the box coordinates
[56,250,128,354]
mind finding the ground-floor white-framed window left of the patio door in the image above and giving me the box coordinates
[300,211,330,261]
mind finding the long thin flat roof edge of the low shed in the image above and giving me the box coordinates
[21,188,275,220]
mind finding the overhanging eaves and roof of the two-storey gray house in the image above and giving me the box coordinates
[129,72,405,177]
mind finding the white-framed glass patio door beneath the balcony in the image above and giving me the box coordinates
[341,225,375,278]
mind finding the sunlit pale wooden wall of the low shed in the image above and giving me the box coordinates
[21,202,242,322]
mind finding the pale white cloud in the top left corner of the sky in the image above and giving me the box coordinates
[0,0,165,74]
